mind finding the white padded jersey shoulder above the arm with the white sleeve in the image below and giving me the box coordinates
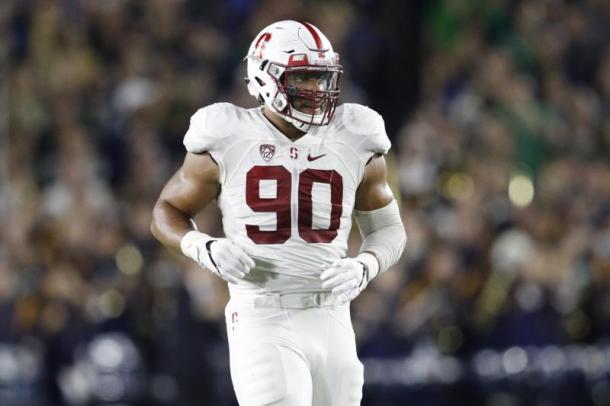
[342,103,391,154]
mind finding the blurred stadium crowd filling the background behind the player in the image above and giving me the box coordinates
[0,0,610,406]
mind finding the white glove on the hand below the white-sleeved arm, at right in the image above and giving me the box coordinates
[320,253,379,304]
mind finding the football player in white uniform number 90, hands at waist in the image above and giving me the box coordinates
[152,21,406,406]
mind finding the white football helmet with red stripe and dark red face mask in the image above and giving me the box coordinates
[245,20,343,131]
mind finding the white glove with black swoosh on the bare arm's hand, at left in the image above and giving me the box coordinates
[180,230,254,284]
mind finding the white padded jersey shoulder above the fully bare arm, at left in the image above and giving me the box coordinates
[183,103,238,153]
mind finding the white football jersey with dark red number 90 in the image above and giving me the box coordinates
[184,103,390,294]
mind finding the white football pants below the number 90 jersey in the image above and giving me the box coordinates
[225,294,364,406]
